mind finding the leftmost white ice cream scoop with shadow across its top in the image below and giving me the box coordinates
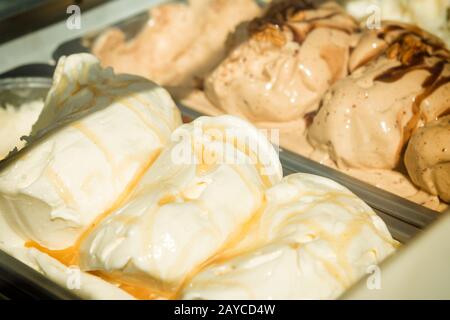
[0,54,181,249]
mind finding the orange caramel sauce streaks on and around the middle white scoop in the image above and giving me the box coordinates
[25,120,278,300]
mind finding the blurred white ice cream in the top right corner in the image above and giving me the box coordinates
[338,0,450,48]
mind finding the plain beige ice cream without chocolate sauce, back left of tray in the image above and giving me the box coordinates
[92,0,261,87]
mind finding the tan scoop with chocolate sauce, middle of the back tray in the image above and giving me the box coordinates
[205,1,357,123]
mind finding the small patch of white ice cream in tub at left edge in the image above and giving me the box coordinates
[0,100,44,160]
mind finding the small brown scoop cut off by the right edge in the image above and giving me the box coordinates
[405,116,450,202]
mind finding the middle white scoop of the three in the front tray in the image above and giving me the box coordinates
[80,116,282,299]
